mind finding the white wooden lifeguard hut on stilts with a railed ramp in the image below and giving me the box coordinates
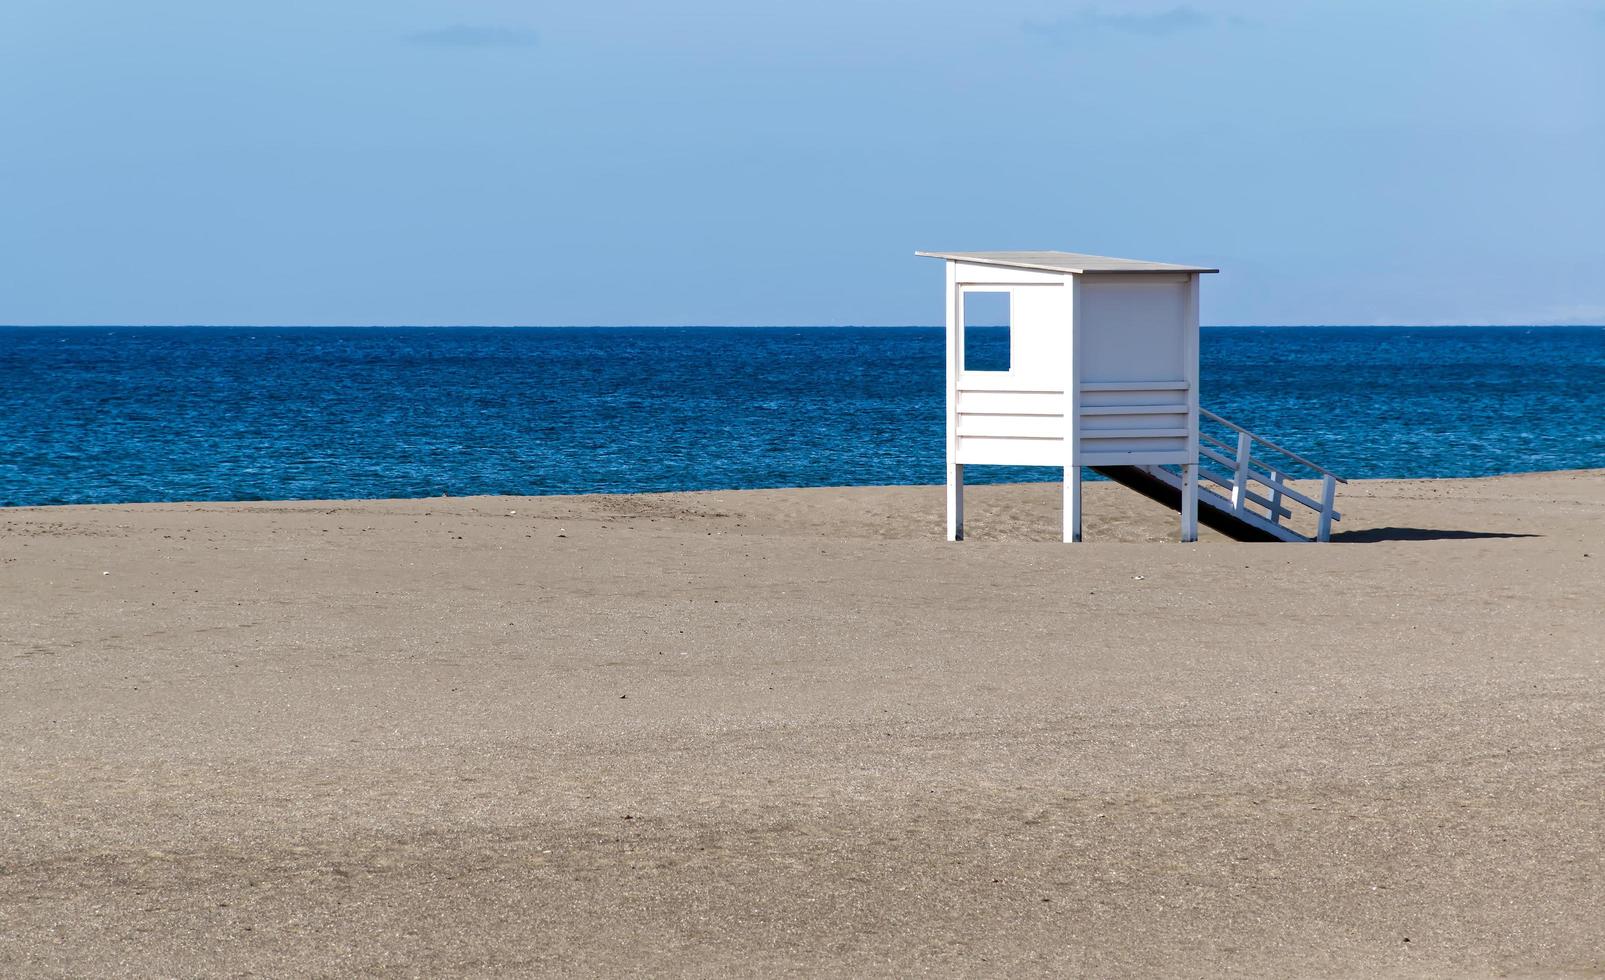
[916,252,1342,541]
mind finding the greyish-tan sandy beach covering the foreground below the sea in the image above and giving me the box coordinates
[0,472,1605,977]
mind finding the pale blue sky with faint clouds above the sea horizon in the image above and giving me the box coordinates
[0,0,1605,324]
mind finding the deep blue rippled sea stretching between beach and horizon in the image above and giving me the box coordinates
[0,327,1605,505]
